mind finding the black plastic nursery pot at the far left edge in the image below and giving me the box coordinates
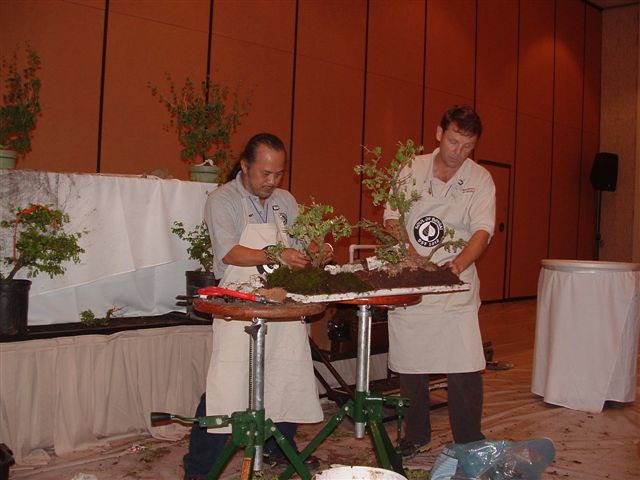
[0,279,31,336]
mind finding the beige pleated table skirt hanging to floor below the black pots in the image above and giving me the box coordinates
[0,325,212,463]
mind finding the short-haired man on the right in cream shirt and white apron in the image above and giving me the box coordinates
[384,106,496,458]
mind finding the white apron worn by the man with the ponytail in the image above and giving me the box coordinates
[207,199,323,433]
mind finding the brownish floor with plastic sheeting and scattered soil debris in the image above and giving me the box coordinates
[9,301,640,480]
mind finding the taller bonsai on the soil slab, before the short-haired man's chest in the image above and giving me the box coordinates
[354,139,423,263]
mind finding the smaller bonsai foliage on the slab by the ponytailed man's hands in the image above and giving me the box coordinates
[287,198,351,267]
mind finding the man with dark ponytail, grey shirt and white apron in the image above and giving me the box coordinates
[184,133,323,480]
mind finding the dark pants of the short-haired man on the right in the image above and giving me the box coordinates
[400,372,485,445]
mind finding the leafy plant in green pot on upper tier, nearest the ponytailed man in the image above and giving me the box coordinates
[148,74,249,183]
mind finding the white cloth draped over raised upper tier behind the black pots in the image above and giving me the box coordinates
[0,170,216,325]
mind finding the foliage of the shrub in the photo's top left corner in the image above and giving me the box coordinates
[0,45,41,156]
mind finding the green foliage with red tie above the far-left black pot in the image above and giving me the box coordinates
[0,203,86,280]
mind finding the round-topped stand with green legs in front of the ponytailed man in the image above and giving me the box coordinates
[151,300,326,480]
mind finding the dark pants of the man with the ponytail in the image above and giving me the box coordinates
[183,393,298,475]
